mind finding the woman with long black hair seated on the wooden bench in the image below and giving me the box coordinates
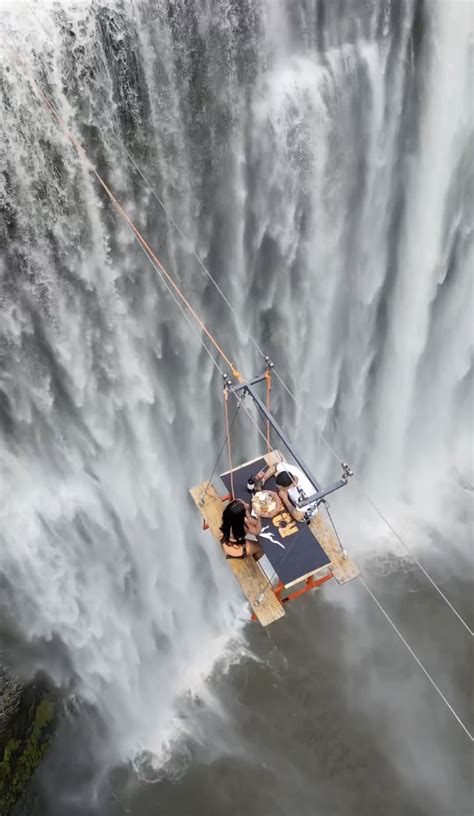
[221,499,263,561]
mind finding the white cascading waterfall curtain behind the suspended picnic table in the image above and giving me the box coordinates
[0,0,474,816]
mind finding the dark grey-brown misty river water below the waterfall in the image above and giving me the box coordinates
[35,543,473,816]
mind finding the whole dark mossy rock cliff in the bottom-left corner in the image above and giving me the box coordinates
[0,666,55,816]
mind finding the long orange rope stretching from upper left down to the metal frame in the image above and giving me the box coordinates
[27,72,243,382]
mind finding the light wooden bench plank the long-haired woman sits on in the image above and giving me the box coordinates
[189,482,285,626]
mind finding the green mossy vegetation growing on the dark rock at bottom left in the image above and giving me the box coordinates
[0,697,55,816]
